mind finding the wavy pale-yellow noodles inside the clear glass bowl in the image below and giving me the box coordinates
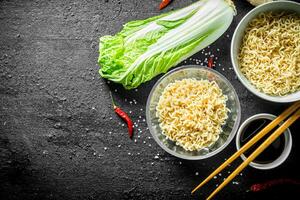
[156,79,229,151]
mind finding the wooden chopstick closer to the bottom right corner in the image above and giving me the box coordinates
[207,109,300,200]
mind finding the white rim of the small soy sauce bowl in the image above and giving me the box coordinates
[235,113,293,170]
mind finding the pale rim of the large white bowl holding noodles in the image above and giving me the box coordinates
[230,1,300,103]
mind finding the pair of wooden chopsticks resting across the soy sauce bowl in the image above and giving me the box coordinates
[192,101,300,200]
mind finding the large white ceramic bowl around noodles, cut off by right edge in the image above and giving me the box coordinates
[230,1,300,103]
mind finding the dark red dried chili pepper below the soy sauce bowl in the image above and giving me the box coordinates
[250,179,300,192]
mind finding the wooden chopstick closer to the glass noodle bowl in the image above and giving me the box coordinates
[192,101,300,194]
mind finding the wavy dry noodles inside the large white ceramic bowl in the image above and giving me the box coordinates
[238,12,300,96]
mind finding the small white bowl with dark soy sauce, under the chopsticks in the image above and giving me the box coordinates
[236,113,292,170]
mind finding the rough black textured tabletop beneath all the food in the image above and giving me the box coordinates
[0,0,300,199]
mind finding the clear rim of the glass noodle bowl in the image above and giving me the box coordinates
[146,65,241,160]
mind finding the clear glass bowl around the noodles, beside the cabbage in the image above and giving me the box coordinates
[146,65,241,160]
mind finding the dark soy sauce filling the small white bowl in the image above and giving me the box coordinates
[240,119,285,164]
